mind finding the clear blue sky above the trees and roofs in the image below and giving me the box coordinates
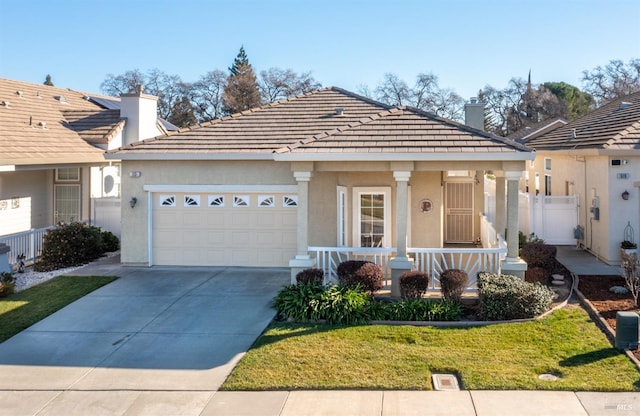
[0,0,640,98]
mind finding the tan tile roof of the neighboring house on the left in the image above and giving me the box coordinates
[0,78,121,166]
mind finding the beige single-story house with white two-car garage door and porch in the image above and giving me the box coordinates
[106,88,533,290]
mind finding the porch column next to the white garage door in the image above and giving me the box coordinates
[289,171,315,284]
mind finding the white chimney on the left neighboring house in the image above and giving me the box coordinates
[120,88,161,145]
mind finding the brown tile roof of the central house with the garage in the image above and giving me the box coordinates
[107,87,531,160]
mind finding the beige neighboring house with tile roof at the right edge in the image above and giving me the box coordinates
[522,93,640,264]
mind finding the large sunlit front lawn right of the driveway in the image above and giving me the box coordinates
[222,306,640,391]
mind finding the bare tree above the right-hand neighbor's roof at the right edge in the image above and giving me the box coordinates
[582,59,640,106]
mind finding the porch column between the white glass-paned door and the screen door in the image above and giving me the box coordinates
[391,171,413,298]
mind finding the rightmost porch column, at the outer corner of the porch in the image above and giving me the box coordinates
[502,171,527,279]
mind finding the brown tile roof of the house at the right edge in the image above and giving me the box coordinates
[527,92,640,151]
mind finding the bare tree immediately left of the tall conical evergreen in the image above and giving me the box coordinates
[189,69,227,121]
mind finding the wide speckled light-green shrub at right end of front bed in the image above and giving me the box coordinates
[478,273,553,321]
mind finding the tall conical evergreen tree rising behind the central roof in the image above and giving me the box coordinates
[222,47,260,114]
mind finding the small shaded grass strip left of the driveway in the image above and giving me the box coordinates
[0,276,116,342]
